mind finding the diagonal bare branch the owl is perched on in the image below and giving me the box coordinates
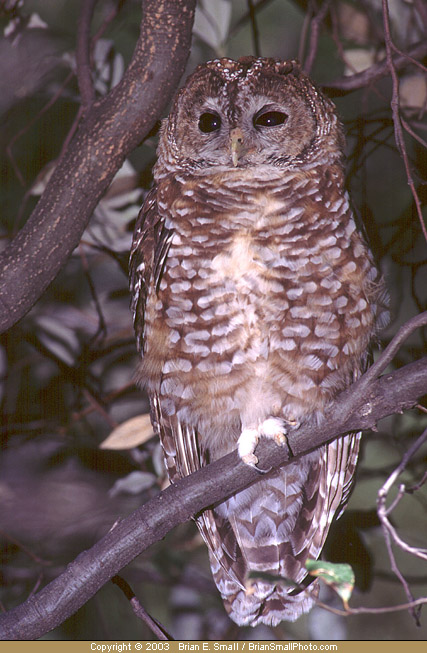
[0,313,427,639]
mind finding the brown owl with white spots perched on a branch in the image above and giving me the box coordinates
[130,57,387,626]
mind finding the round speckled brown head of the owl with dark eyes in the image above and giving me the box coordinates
[156,57,344,176]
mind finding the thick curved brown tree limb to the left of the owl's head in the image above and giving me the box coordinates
[0,0,195,332]
